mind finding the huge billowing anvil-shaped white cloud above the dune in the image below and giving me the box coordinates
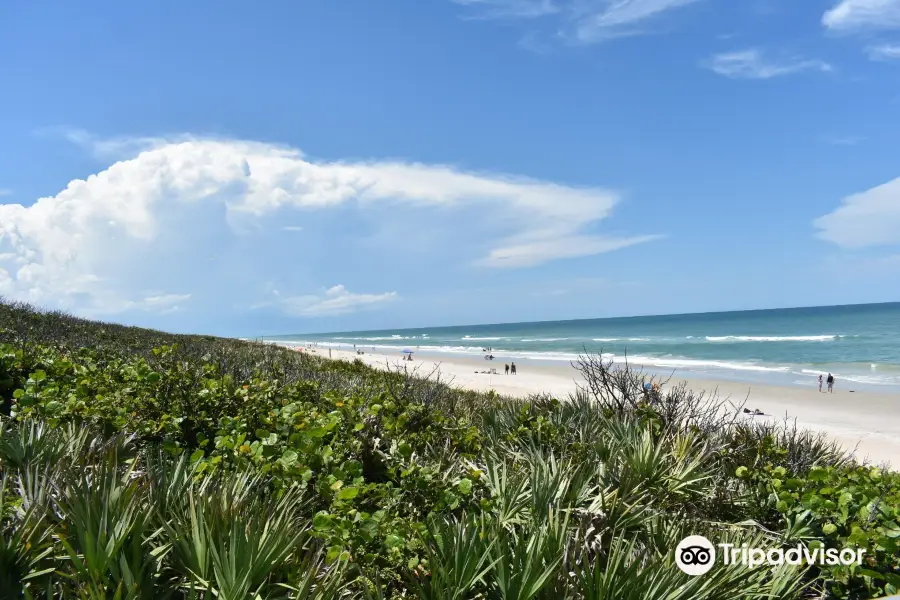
[0,138,653,314]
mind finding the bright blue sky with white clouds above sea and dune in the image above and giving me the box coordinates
[0,0,900,335]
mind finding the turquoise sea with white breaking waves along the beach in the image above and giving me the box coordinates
[267,303,900,391]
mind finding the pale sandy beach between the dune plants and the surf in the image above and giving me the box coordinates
[305,347,900,468]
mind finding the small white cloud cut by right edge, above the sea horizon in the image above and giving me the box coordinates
[813,178,900,248]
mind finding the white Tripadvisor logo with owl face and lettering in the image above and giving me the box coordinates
[675,535,866,575]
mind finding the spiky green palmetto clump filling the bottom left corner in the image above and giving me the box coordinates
[0,427,334,599]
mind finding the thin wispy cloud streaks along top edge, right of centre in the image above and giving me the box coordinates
[453,0,700,47]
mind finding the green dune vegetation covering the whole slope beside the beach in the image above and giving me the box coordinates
[0,303,900,600]
